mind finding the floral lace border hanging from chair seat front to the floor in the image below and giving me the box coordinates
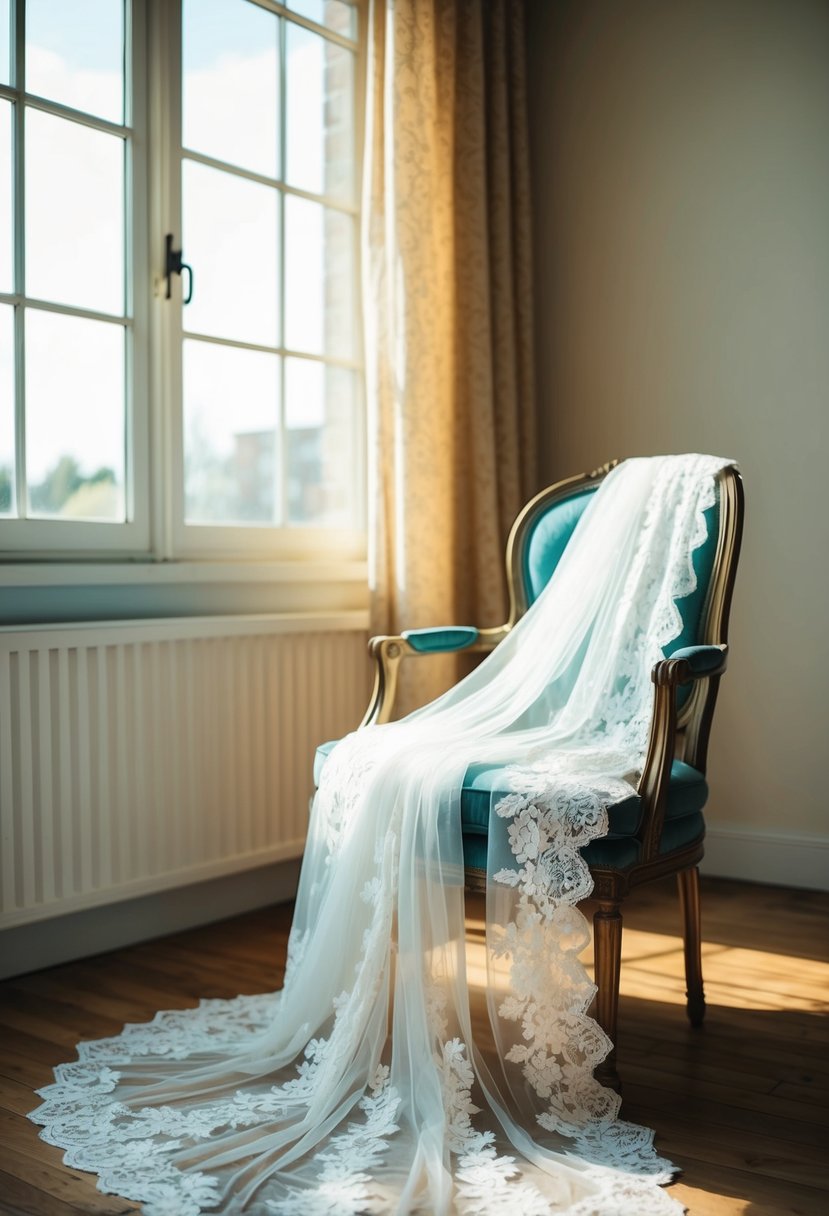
[494,776,671,1181]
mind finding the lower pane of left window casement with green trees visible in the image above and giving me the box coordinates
[26,309,125,522]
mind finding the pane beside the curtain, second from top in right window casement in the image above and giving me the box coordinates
[286,23,354,201]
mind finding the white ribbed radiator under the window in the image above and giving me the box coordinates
[0,612,368,928]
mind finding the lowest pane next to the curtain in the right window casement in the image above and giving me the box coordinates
[284,359,359,528]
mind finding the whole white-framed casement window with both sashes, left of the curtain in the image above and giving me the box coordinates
[0,0,365,558]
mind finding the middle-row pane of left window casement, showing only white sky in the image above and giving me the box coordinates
[26,109,124,315]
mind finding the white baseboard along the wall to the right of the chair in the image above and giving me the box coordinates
[700,823,829,891]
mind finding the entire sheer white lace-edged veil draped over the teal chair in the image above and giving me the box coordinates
[32,456,728,1216]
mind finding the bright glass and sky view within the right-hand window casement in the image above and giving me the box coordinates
[182,0,355,525]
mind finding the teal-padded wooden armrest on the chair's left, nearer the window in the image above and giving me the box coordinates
[360,625,509,726]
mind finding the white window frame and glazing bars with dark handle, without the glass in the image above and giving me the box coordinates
[0,0,367,566]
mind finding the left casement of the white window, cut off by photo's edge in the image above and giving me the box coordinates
[0,0,148,551]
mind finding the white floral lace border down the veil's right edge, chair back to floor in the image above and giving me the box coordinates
[483,459,715,1191]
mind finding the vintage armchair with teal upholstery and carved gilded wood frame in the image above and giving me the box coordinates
[315,461,743,1085]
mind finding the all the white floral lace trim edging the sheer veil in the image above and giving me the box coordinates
[32,457,714,1216]
